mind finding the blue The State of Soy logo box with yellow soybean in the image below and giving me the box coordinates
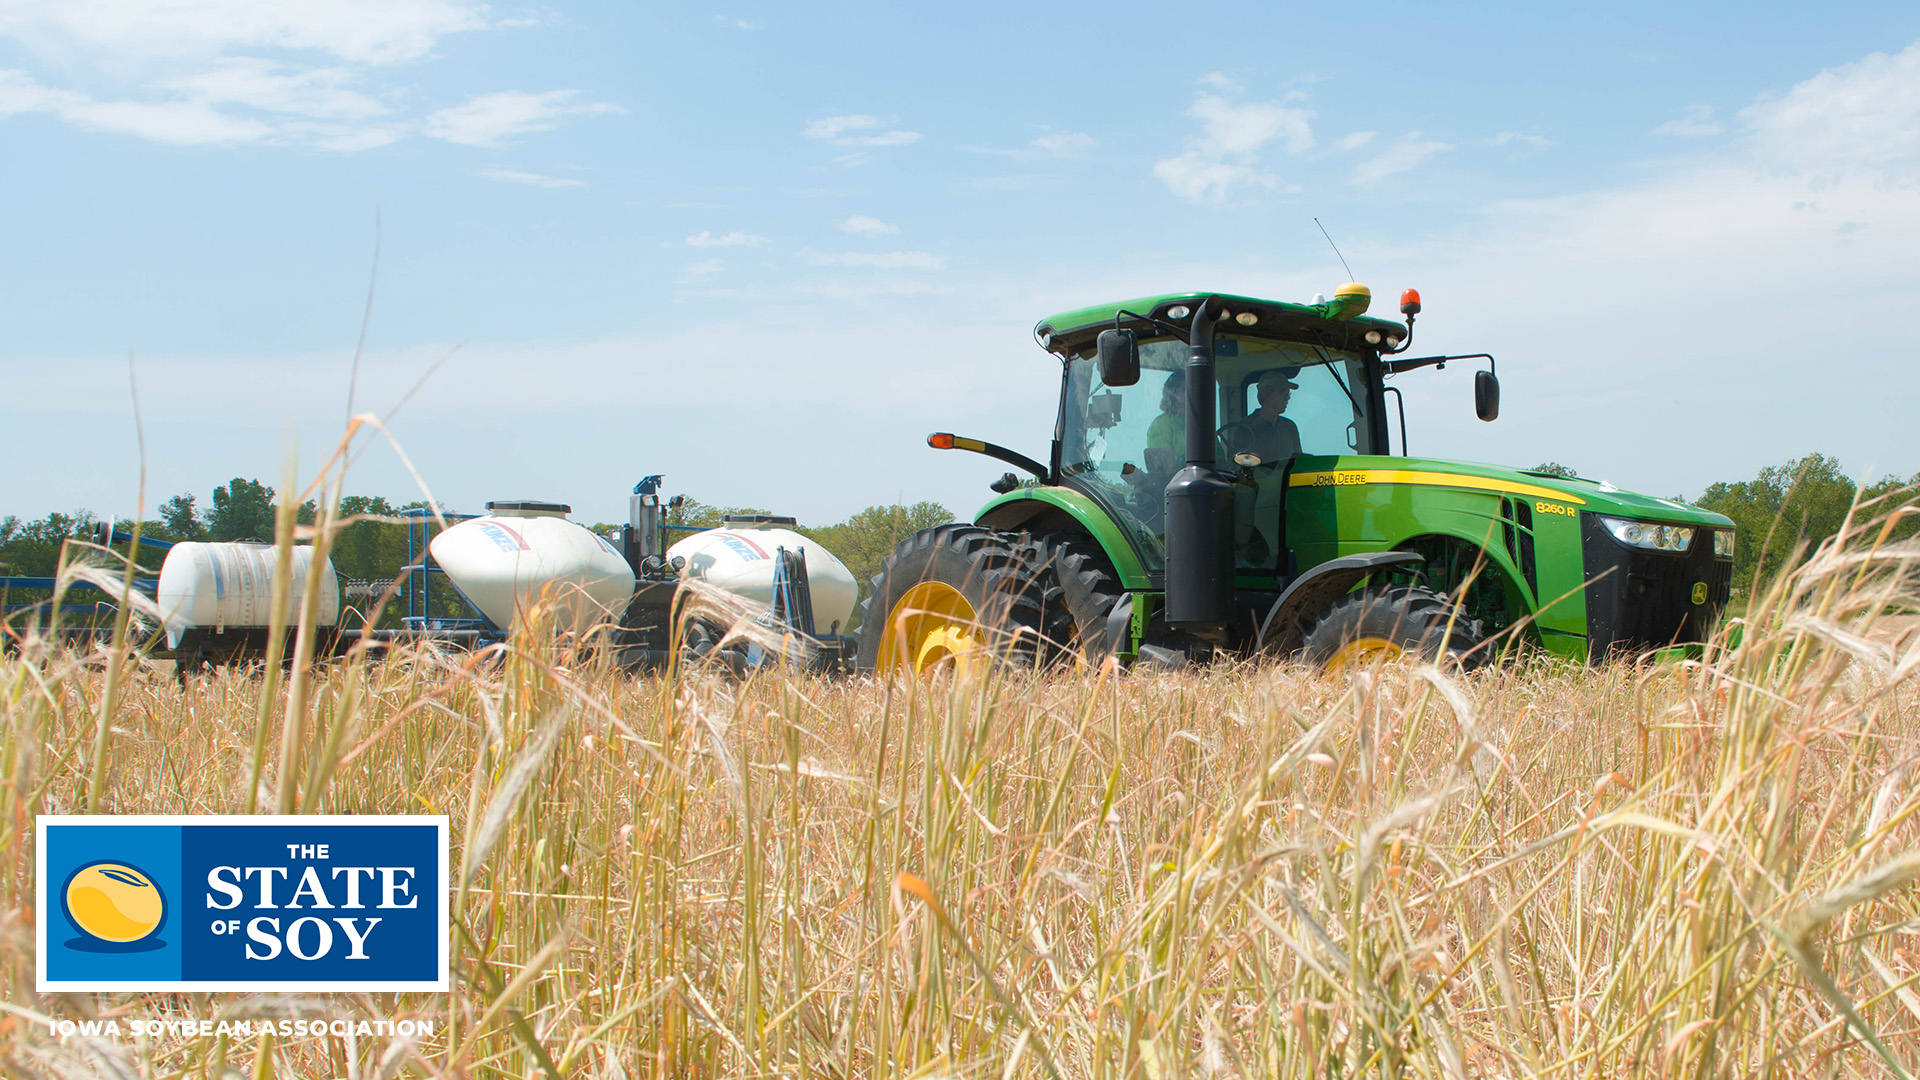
[35,815,449,994]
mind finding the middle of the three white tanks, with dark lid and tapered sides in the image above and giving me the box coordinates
[426,502,634,628]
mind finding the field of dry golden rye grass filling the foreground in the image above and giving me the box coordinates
[0,511,1920,1080]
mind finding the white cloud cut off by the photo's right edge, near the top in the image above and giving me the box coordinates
[1740,42,1920,169]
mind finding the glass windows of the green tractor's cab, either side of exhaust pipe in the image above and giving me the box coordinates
[1060,334,1373,573]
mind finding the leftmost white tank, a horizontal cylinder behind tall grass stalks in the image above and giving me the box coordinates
[154,542,340,650]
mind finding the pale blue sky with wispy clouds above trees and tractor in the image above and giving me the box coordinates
[0,0,1920,523]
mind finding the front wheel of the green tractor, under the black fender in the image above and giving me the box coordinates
[1300,584,1486,673]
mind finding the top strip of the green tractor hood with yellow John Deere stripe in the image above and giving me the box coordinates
[1320,449,1734,528]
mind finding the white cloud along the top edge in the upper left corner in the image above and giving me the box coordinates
[0,0,486,63]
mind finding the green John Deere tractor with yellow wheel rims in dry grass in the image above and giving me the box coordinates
[858,284,1734,671]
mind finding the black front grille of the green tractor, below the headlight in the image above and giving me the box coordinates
[1580,513,1734,659]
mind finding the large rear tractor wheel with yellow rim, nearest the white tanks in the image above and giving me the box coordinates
[858,525,1046,673]
